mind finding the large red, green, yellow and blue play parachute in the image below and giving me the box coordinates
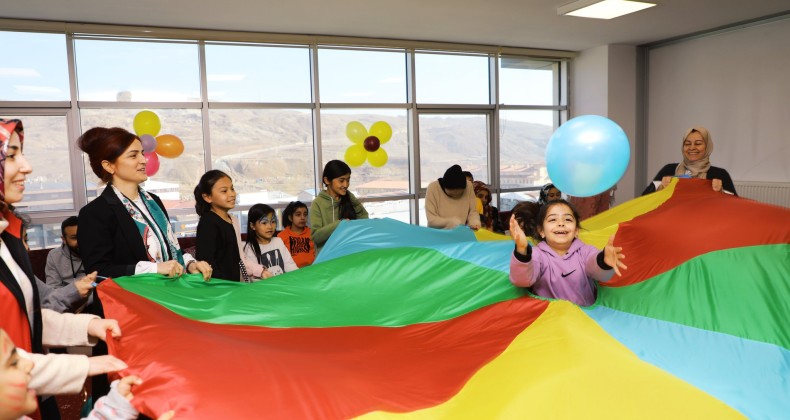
[99,180,790,419]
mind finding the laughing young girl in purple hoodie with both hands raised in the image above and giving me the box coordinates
[510,200,627,306]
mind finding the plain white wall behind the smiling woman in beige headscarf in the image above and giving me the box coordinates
[641,19,790,185]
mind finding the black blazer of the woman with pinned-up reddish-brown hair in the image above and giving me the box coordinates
[77,185,172,277]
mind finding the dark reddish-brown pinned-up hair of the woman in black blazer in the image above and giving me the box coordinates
[77,127,140,183]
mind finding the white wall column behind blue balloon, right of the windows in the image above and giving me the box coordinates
[570,45,641,204]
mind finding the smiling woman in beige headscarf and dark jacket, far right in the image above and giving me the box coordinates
[642,127,738,195]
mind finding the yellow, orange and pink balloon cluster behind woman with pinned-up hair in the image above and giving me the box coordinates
[134,110,184,176]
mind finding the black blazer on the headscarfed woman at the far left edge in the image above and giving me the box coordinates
[0,221,44,353]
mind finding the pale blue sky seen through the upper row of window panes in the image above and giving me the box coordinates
[0,32,553,125]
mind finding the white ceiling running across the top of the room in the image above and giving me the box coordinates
[0,0,790,51]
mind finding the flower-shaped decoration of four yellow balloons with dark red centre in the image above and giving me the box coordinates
[345,121,392,168]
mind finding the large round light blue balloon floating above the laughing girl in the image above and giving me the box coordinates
[546,115,631,197]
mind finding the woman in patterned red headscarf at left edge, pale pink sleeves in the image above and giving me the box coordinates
[0,119,126,418]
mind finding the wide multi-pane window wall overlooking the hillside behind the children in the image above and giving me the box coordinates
[0,29,567,246]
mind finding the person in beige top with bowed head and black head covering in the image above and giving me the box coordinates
[425,165,480,230]
